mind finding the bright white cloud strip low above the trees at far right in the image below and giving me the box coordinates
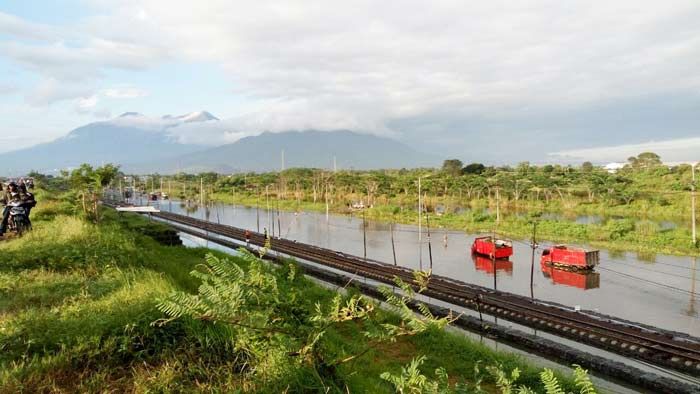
[550,137,700,163]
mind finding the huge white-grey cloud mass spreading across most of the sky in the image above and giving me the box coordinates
[0,0,700,154]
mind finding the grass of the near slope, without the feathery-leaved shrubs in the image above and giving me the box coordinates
[0,191,580,393]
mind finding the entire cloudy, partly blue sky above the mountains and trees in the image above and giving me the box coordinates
[0,0,700,163]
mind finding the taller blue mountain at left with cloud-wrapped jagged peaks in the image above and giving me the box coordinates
[0,111,218,175]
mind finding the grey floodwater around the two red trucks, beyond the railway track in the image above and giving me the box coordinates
[154,201,700,336]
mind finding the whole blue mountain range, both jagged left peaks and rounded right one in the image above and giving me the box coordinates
[0,111,439,176]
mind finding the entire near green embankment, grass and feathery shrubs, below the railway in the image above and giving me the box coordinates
[0,169,594,393]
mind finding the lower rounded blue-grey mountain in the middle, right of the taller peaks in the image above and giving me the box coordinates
[125,131,440,174]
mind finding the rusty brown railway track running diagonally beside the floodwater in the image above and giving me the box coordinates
[135,208,700,377]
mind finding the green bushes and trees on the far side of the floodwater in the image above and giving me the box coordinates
[136,152,700,255]
